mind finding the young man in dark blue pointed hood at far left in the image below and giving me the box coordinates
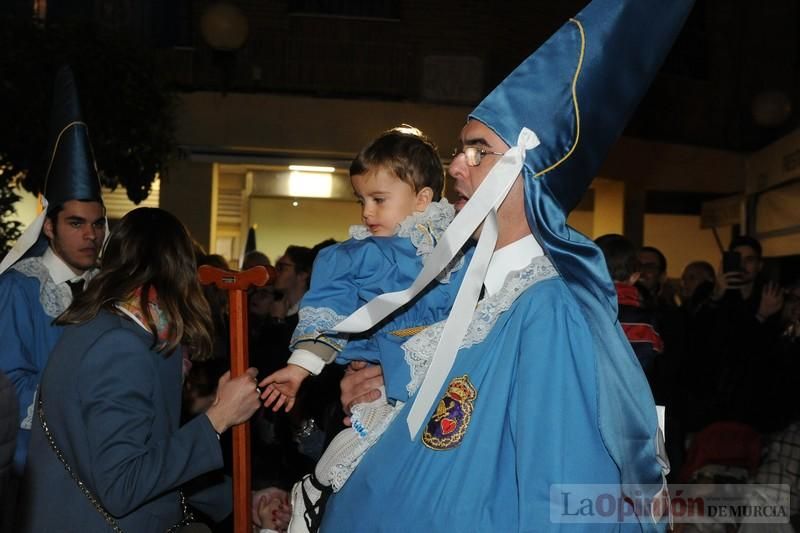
[0,67,106,475]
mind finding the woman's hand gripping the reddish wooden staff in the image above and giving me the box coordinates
[206,368,261,433]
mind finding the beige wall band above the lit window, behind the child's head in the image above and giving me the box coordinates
[177,92,470,160]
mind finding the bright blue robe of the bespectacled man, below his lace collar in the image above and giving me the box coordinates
[321,277,639,533]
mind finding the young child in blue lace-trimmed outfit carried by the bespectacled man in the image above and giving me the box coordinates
[259,126,466,531]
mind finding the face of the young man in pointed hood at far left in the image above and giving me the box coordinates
[43,200,106,275]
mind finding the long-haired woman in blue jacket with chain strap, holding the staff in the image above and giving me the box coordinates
[21,208,268,532]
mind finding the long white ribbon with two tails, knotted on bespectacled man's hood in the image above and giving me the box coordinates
[333,128,539,440]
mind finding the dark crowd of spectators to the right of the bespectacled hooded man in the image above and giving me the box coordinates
[596,235,800,521]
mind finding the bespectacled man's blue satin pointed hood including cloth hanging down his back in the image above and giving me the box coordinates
[470,0,693,530]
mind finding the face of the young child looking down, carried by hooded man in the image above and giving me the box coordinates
[350,167,432,237]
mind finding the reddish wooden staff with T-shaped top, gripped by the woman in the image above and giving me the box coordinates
[198,265,275,533]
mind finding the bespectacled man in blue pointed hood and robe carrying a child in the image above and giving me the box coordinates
[321,0,692,533]
